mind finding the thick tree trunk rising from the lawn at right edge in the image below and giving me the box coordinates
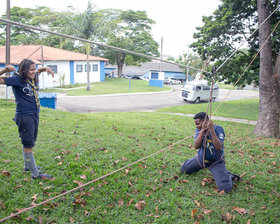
[254,0,280,138]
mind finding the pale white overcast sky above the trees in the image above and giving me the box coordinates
[0,0,220,58]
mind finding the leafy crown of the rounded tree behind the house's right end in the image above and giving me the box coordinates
[100,10,159,76]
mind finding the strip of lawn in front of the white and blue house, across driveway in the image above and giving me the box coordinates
[40,78,170,96]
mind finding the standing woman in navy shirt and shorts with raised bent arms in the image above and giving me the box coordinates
[0,59,54,179]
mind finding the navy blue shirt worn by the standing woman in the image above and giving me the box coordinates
[4,74,40,115]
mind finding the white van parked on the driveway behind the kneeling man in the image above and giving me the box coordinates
[181,81,219,103]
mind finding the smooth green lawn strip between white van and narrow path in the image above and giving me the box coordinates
[157,99,259,120]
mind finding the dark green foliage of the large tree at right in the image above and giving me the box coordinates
[191,0,280,86]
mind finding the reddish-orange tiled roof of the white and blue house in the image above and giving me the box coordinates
[0,45,109,65]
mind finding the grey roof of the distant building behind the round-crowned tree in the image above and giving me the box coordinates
[105,62,184,76]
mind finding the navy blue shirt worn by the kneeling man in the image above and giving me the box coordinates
[194,125,225,161]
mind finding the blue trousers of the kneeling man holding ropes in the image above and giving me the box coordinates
[181,156,233,193]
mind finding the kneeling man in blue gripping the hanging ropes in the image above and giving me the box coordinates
[181,112,240,193]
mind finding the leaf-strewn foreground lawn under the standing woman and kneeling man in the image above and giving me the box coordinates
[0,100,280,223]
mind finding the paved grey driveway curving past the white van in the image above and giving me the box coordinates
[57,85,259,113]
